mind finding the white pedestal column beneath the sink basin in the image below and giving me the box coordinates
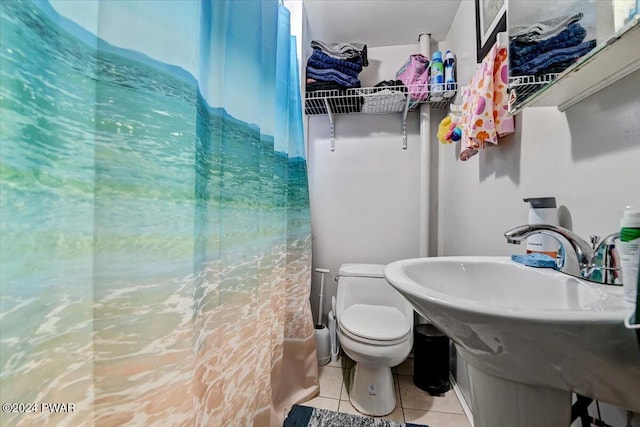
[467,365,571,427]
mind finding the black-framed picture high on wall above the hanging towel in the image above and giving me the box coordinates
[476,0,507,63]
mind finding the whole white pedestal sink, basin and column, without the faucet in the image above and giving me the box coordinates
[385,257,640,427]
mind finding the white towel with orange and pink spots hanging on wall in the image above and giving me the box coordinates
[460,44,514,160]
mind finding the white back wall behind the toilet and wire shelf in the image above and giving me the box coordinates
[307,44,432,324]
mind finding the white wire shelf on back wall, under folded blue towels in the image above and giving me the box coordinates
[305,83,458,115]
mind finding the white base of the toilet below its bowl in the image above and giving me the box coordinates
[349,363,396,417]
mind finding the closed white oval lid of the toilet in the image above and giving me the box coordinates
[338,304,411,341]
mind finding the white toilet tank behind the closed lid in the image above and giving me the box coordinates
[336,264,413,321]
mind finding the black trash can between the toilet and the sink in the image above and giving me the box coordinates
[413,325,451,395]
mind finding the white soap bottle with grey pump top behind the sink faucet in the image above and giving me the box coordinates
[522,197,560,258]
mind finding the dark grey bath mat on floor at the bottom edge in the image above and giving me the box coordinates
[283,405,428,427]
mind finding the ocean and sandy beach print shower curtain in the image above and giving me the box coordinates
[0,0,317,427]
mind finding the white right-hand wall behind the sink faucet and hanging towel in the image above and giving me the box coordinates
[438,1,640,427]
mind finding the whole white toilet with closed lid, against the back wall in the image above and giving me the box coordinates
[336,264,413,416]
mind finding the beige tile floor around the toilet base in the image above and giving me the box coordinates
[302,357,470,427]
